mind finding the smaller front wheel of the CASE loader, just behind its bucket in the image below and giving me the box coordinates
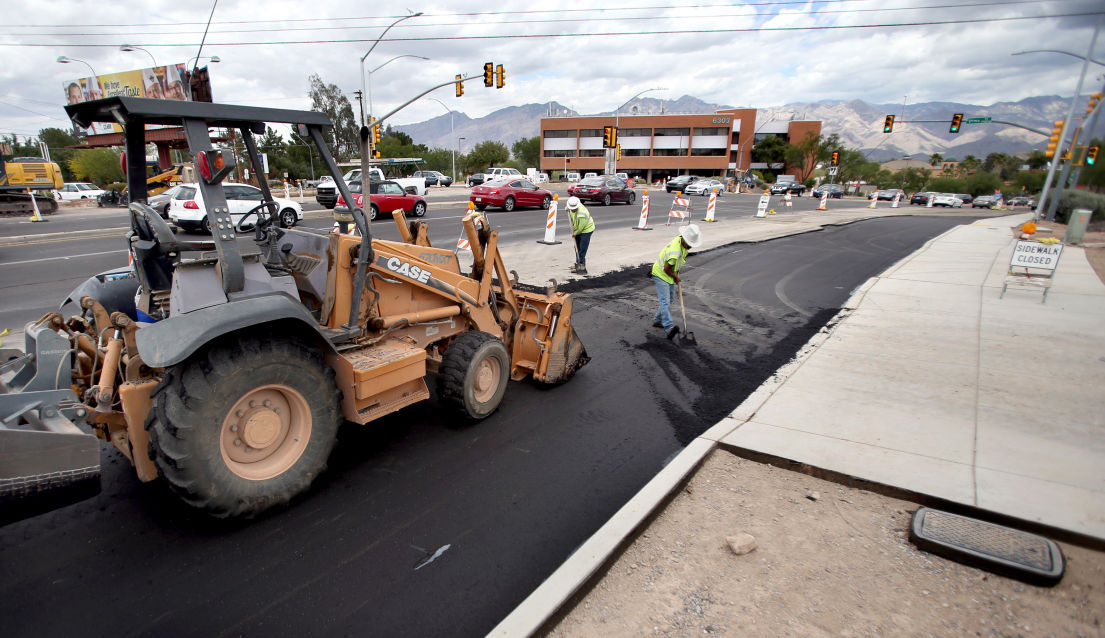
[438,331,511,421]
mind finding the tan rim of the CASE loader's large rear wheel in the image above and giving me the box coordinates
[219,385,312,481]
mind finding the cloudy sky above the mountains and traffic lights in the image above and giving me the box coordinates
[0,0,1105,141]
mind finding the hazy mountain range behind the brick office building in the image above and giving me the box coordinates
[394,95,1105,161]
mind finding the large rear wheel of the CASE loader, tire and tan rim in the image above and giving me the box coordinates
[146,337,341,517]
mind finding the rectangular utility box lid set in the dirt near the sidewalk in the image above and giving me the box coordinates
[909,508,1063,586]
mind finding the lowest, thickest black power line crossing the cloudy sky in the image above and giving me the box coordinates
[0,11,1102,49]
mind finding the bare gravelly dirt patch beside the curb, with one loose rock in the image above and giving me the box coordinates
[547,449,1105,637]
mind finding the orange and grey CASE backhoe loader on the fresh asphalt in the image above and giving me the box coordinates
[0,97,589,517]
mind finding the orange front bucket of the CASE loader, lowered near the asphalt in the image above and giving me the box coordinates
[514,290,591,384]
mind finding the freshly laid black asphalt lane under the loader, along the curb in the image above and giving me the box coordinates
[0,207,976,636]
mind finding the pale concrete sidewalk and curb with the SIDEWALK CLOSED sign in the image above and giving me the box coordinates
[490,213,1105,636]
